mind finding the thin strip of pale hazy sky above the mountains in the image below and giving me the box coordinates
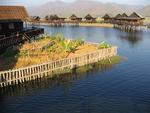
[0,0,150,6]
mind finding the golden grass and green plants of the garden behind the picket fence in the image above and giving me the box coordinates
[0,33,120,70]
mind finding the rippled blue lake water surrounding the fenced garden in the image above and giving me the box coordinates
[0,26,150,113]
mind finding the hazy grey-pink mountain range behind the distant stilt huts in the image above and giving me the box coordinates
[27,0,150,17]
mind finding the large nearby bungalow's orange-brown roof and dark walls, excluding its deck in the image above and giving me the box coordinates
[0,6,28,35]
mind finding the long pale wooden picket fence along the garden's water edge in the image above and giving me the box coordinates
[0,46,117,87]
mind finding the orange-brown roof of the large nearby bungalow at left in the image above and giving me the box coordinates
[0,6,28,21]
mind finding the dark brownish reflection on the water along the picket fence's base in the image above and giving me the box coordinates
[0,64,116,98]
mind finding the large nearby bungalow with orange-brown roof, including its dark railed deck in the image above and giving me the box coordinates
[0,6,44,49]
